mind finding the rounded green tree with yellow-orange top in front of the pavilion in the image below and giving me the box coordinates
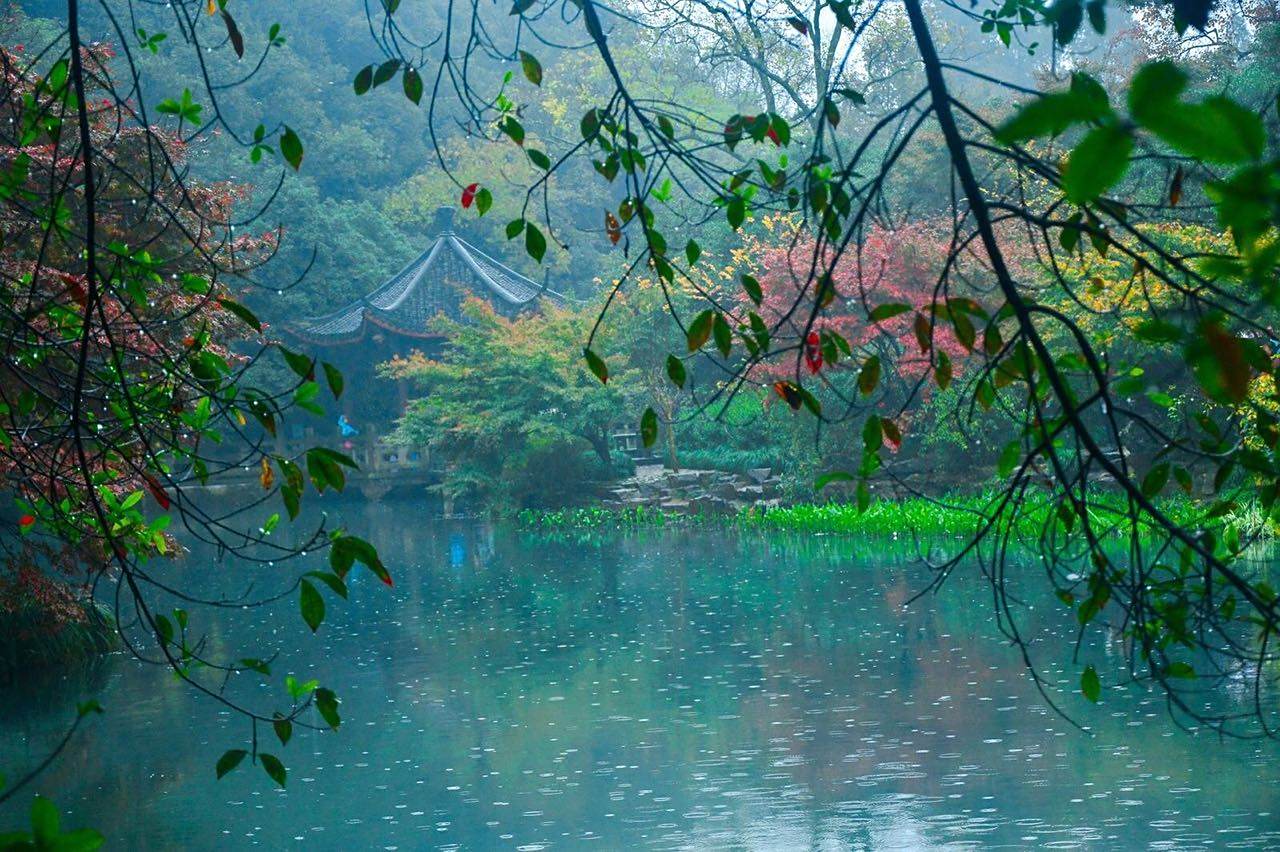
[380,299,631,508]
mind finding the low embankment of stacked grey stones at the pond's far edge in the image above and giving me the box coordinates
[600,464,781,514]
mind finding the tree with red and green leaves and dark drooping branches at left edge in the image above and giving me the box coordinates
[0,0,390,834]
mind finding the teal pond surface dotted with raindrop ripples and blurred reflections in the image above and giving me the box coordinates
[0,503,1280,849]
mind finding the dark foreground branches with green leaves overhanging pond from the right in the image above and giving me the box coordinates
[360,0,1280,733]
